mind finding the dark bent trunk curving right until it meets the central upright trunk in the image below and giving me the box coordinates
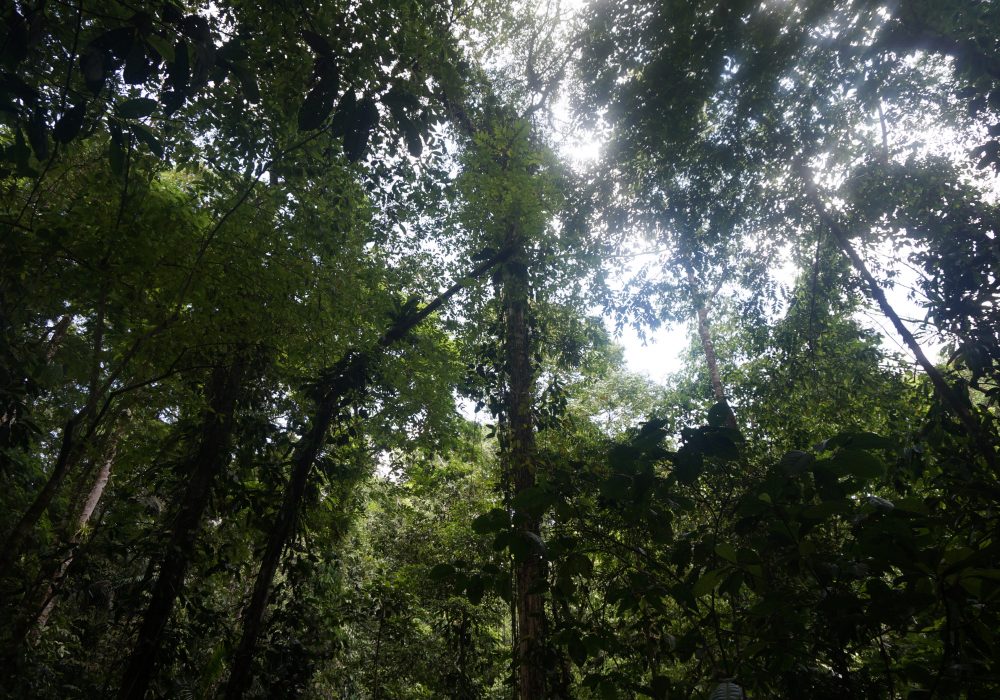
[225,249,510,700]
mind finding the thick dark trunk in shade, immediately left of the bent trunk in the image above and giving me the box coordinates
[118,355,247,700]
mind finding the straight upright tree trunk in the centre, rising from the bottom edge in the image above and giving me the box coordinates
[502,225,546,700]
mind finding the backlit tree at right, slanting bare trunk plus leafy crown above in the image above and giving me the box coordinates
[583,3,995,454]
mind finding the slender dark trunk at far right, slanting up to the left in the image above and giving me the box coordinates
[799,167,998,471]
